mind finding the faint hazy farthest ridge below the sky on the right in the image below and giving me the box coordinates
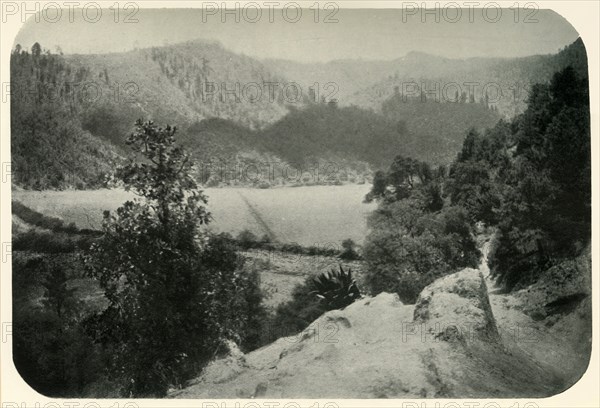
[268,39,587,117]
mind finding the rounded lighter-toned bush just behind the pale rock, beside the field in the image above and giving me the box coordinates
[364,200,480,303]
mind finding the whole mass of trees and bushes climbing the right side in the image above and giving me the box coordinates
[363,66,591,302]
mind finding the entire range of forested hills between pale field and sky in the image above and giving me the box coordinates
[11,40,587,189]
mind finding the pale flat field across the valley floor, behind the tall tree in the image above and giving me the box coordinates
[12,184,375,246]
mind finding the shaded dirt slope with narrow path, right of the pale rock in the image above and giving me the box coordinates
[480,241,592,391]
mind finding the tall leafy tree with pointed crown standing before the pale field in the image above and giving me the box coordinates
[86,121,261,396]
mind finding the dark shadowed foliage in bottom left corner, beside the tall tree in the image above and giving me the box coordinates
[13,254,110,397]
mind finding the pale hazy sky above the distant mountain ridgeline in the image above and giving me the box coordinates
[15,7,578,62]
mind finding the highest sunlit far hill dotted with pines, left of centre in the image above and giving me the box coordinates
[66,41,286,132]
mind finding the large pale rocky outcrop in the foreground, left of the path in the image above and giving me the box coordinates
[170,269,557,398]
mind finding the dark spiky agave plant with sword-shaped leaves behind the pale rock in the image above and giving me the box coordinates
[312,265,361,310]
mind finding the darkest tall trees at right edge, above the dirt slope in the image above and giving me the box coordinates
[490,67,591,289]
